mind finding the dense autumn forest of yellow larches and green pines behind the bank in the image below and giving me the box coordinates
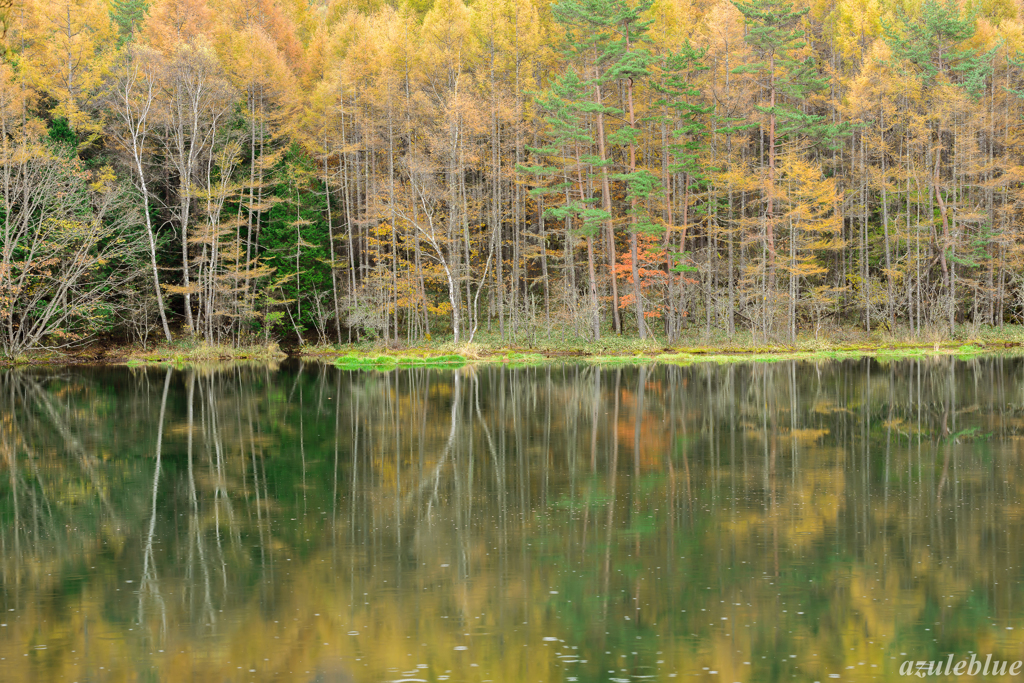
[0,0,1024,354]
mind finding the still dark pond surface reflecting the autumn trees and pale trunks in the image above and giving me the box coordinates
[0,357,1024,683]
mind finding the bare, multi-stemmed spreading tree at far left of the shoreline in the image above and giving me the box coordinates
[0,67,142,354]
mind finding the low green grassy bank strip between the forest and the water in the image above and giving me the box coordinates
[0,326,1024,371]
